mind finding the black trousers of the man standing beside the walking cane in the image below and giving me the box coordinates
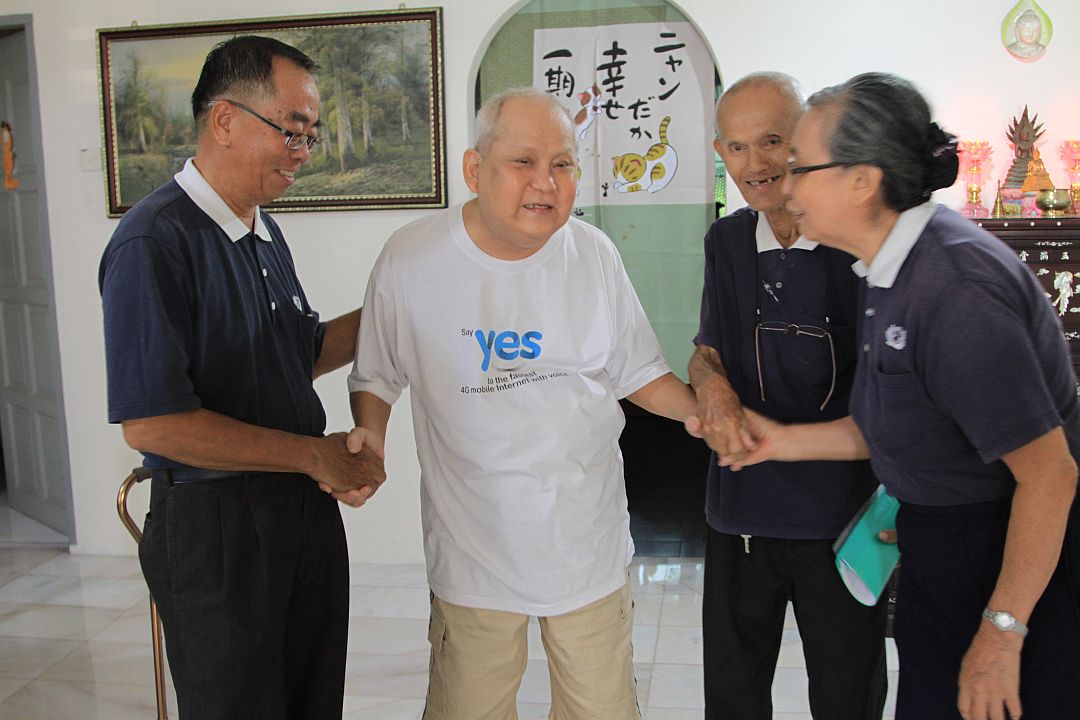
[139,474,349,720]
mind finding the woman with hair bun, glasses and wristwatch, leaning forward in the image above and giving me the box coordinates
[704,73,1080,720]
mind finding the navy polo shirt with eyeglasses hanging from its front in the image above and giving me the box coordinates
[694,209,877,540]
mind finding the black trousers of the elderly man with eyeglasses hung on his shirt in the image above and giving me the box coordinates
[702,528,888,720]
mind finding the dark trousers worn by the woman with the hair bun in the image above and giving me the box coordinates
[894,501,1080,720]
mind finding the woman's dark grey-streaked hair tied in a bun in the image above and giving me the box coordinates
[807,72,959,212]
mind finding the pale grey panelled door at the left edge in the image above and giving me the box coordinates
[0,27,71,536]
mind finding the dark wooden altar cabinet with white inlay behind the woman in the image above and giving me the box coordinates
[973,217,1080,375]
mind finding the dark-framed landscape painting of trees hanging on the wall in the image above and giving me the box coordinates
[97,8,447,217]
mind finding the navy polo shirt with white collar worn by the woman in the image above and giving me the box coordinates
[851,204,1080,505]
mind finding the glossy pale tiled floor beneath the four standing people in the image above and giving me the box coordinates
[0,547,896,720]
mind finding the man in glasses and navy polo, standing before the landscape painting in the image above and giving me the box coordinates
[99,36,384,720]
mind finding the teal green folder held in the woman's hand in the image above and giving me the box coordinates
[833,485,900,606]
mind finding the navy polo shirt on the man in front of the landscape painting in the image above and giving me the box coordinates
[98,161,326,468]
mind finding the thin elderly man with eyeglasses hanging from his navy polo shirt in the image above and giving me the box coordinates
[690,73,886,720]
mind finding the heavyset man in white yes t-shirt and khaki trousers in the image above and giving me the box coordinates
[349,89,696,720]
